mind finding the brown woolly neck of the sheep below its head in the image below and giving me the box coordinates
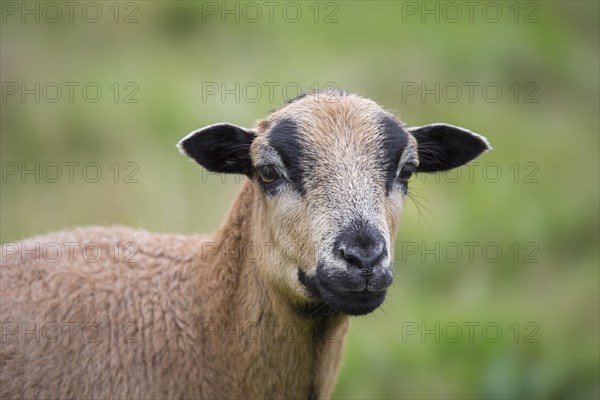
[204,182,348,398]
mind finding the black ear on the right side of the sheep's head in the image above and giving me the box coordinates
[406,124,491,172]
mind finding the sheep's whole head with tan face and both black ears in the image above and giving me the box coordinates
[180,92,489,315]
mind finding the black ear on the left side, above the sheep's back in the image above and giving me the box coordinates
[177,123,256,176]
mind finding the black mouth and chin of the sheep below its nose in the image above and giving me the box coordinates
[298,270,387,316]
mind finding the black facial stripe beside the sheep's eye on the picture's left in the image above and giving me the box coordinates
[269,119,314,195]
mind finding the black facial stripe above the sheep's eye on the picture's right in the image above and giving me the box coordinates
[379,115,408,194]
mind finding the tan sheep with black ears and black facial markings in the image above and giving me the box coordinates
[0,91,490,399]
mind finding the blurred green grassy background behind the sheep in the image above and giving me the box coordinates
[0,1,600,399]
